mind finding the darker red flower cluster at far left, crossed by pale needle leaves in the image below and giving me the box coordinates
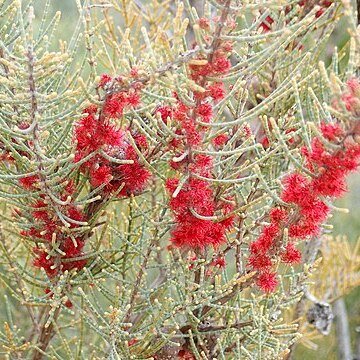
[20,179,86,277]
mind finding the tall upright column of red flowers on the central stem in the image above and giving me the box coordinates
[165,28,233,248]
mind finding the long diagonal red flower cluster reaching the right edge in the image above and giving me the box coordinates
[249,124,360,292]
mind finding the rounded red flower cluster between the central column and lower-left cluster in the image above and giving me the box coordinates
[74,76,151,196]
